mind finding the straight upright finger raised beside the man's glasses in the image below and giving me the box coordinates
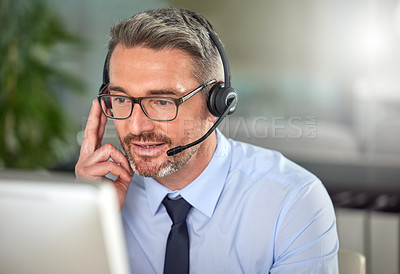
[81,100,102,154]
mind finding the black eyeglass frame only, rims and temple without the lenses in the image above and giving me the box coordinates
[97,80,217,122]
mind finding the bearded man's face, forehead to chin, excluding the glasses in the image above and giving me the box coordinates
[110,44,214,177]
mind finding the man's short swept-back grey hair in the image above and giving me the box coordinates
[108,8,223,93]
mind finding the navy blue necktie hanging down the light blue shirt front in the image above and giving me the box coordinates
[163,197,192,274]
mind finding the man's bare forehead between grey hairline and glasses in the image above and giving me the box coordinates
[109,44,197,93]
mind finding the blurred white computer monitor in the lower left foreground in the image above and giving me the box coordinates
[0,172,129,274]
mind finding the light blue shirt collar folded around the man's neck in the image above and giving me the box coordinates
[143,130,231,217]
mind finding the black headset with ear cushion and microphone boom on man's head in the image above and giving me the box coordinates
[99,31,238,156]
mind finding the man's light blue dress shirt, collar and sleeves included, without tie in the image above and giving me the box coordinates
[122,131,339,274]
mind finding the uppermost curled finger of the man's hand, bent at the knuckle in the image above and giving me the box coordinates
[85,144,133,175]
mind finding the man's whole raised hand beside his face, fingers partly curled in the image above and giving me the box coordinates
[75,100,133,209]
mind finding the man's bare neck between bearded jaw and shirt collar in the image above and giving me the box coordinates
[155,131,217,190]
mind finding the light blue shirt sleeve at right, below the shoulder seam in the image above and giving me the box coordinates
[270,181,339,274]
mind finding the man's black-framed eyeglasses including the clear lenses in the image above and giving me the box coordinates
[97,80,216,121]
